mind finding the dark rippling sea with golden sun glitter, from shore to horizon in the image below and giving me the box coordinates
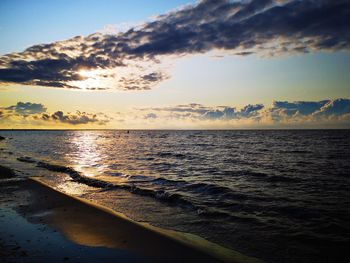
[0,130,350,262]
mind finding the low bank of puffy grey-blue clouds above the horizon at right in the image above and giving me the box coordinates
[139,99,350,127]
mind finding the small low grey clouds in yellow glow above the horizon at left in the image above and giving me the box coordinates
[0,102,111,126]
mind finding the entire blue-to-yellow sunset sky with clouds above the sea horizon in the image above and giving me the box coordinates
[0,0,350,129]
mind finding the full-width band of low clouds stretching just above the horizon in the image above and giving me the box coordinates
[0,98,350,129]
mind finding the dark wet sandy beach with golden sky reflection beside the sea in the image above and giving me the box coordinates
[0,166,260,262]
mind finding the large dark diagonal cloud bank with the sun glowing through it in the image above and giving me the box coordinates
[0,0,350,90]
